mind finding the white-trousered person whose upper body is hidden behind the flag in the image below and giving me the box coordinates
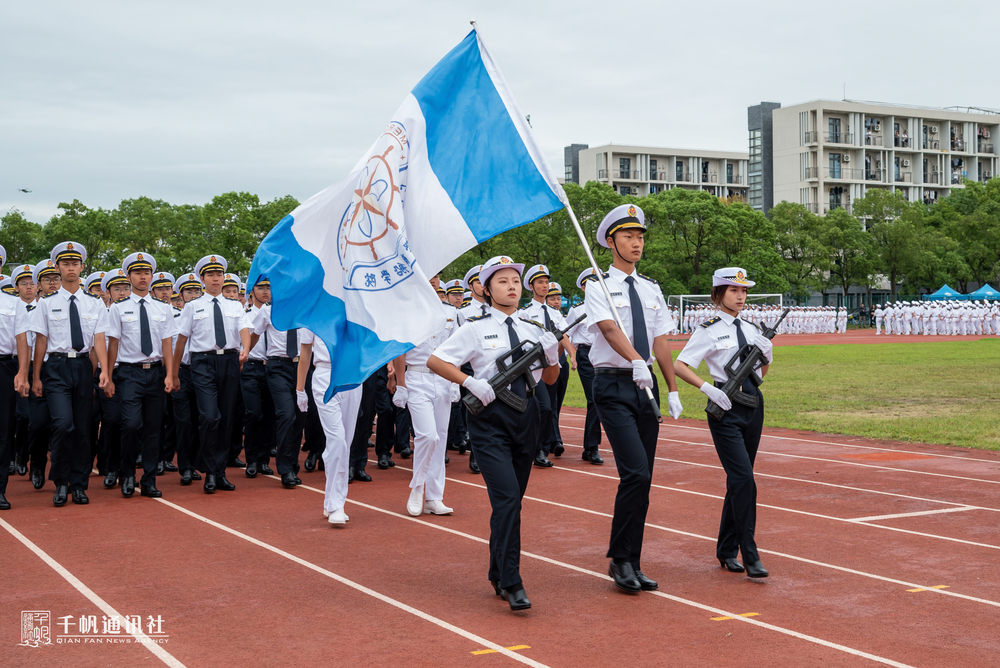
[295,328,362,525]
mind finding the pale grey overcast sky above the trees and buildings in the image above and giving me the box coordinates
[0,0,1000,222]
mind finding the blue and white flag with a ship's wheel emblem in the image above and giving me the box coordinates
[247,30,565,400]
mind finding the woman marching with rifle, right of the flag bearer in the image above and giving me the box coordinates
[674,267,772,578]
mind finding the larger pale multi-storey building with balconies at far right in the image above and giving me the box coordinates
[764,100,1000,214]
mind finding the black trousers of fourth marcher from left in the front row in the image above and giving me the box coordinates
[191,351,240,476]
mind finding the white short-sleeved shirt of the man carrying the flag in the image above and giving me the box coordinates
[584,267,672,369]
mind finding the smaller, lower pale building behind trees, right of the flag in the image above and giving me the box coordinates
[579,144,749,199]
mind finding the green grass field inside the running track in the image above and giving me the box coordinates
[565,338,1000,450]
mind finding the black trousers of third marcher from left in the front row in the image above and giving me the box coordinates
[116,363,167,487]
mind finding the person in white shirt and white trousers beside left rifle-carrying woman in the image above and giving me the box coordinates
[392,278,460,517]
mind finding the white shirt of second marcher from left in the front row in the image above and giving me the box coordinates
[30,287,108,354]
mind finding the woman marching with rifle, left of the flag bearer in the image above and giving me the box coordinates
[427,255,559,610]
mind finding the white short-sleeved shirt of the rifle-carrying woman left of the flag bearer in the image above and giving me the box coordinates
[434,306,545,383]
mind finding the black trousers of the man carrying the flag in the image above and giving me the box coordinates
[594,367,660,568]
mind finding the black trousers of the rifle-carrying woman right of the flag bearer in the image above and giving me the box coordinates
[708,390,764,563]
